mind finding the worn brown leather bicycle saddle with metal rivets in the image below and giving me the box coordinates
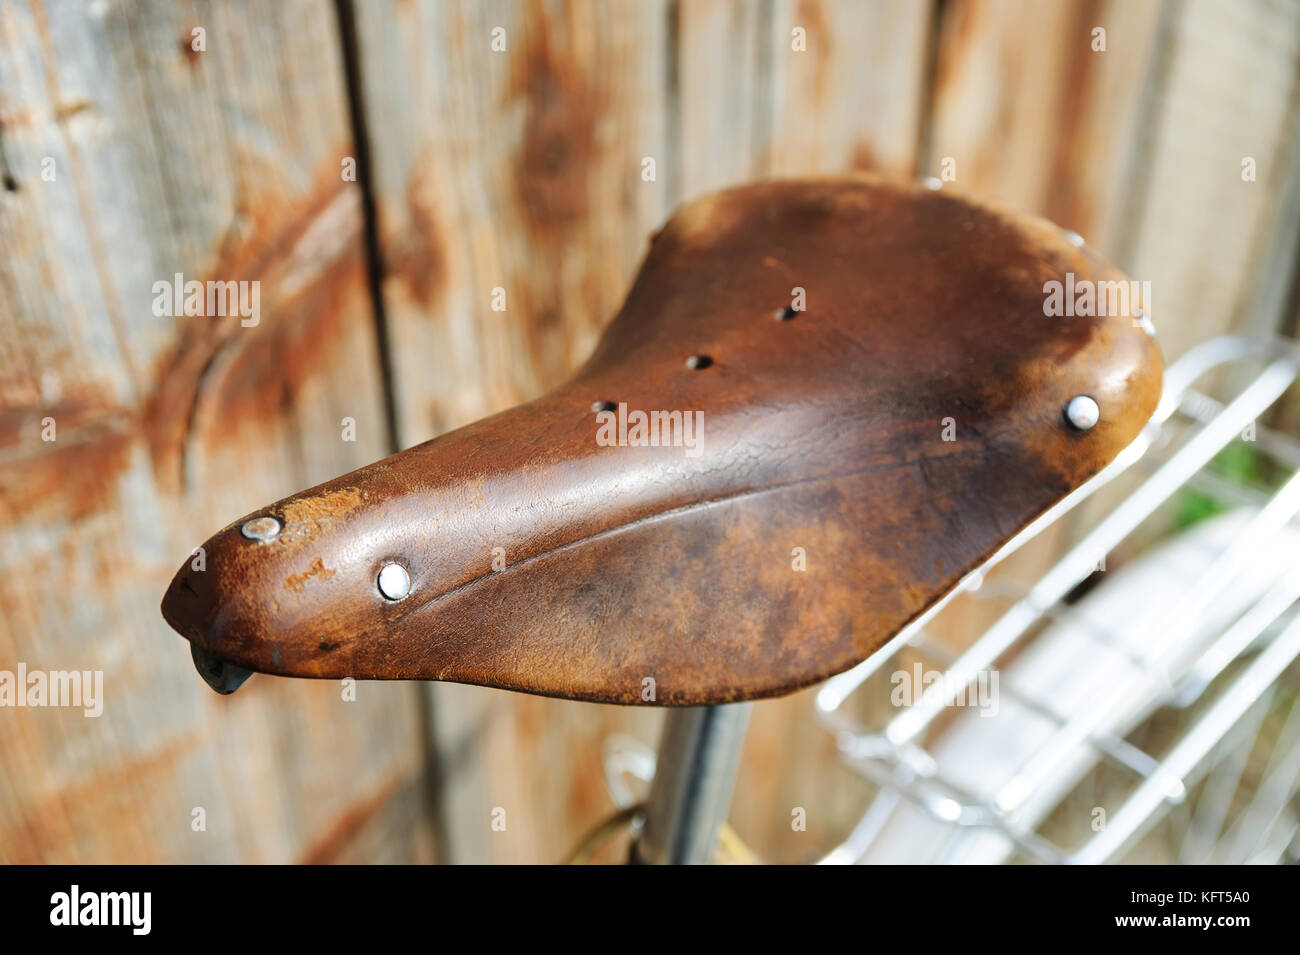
[163,177,1161,704]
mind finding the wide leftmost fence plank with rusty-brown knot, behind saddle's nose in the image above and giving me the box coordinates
[0,1,430,863]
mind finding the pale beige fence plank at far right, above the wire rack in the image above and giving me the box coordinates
[1118,0,1300,357]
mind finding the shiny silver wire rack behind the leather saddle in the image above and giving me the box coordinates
[815,337,1300,863]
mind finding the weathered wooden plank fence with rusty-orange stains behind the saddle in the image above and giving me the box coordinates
[0,0,1300,863]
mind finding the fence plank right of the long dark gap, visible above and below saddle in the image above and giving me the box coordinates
[345,3,668,861]
